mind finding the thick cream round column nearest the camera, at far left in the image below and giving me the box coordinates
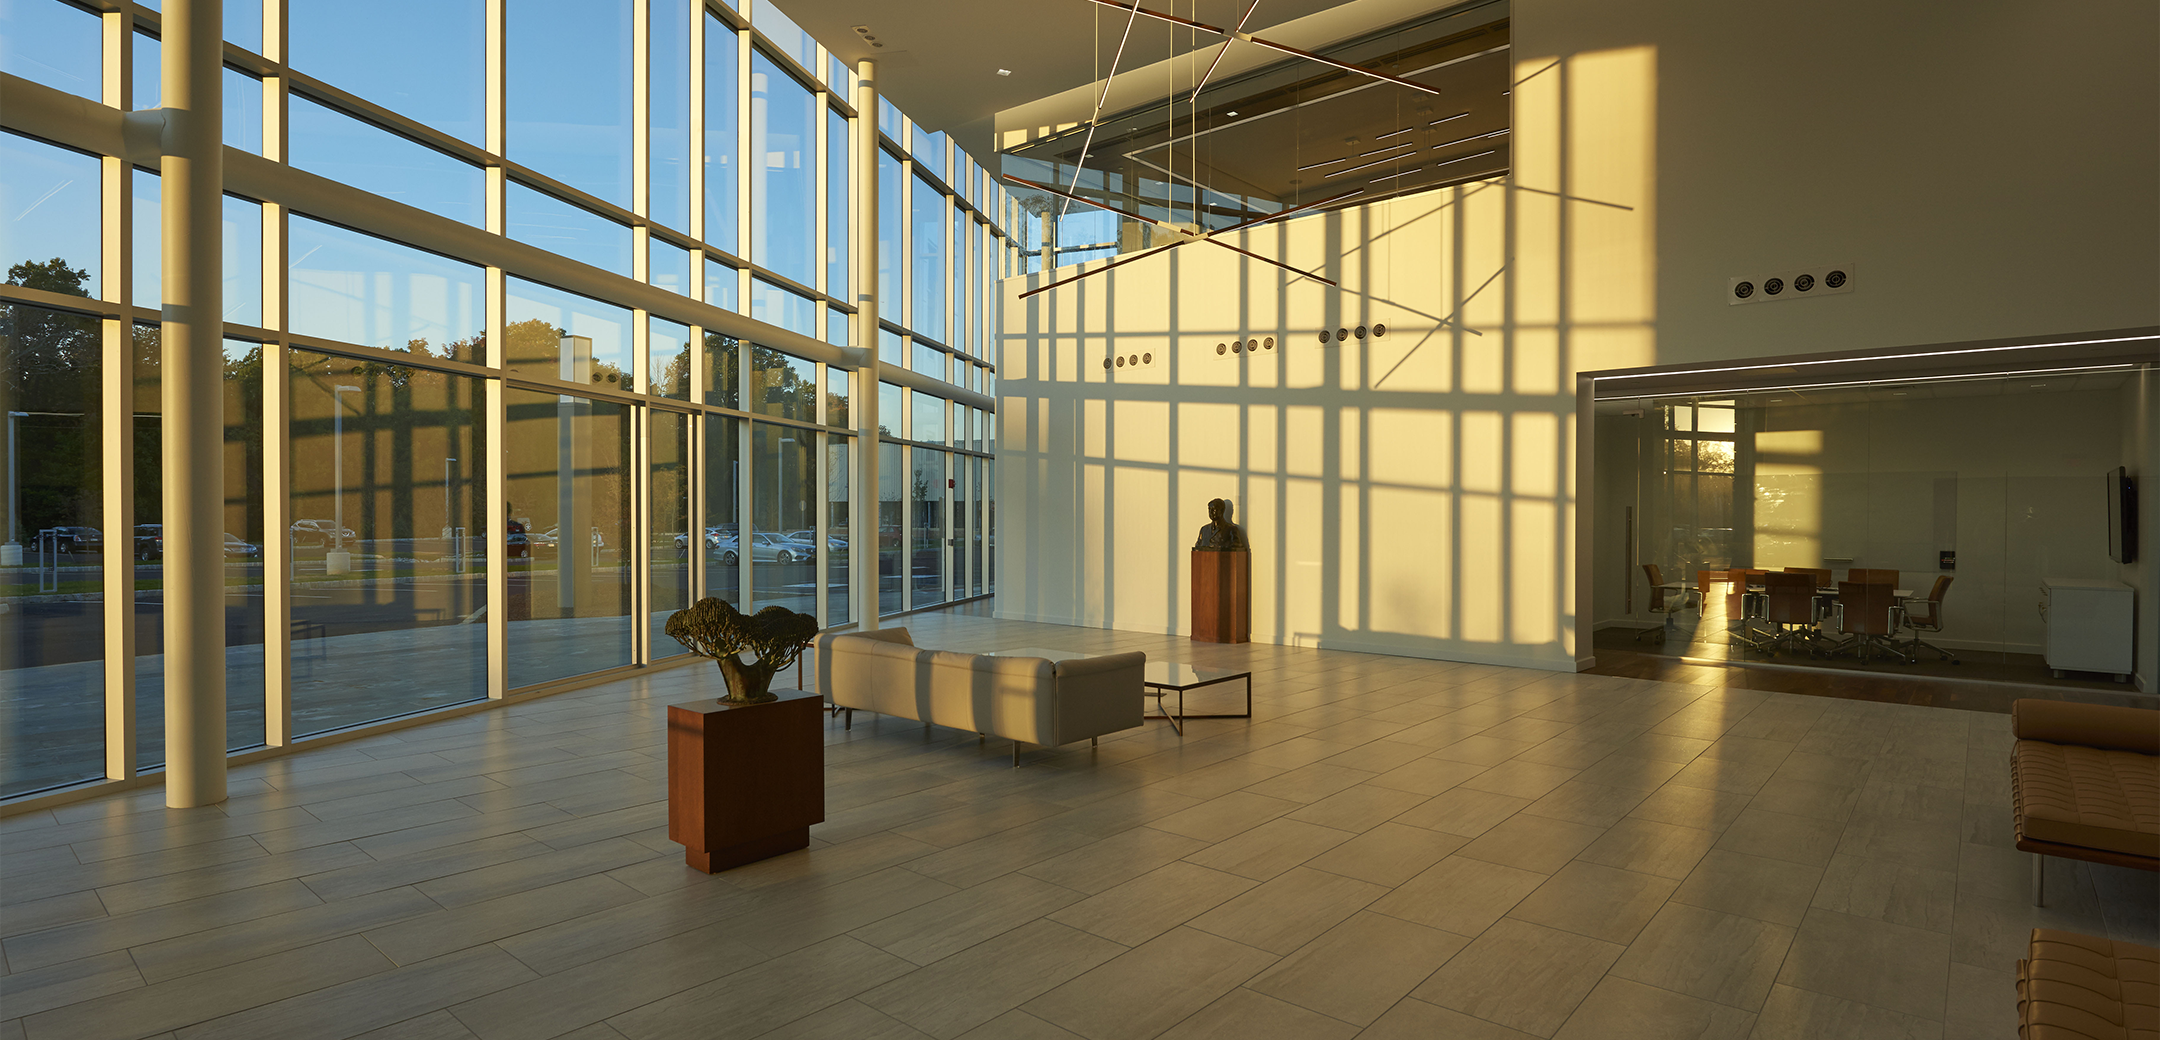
[160,0,225,809]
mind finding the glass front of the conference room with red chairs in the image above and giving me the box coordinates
[1594,363,2138,690]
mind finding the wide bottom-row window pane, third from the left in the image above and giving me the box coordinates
[279,350,486,735]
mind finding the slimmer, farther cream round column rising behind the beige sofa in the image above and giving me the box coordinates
[847,58,872,631]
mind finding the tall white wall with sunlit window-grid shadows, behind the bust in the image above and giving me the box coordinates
[998,0,2160,668]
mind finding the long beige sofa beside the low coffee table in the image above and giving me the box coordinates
[816,629,1147,765]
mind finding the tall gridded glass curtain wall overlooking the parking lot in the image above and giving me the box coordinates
[0,0,1011,798]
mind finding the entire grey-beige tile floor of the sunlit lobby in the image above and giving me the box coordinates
[0,608,2160,1040]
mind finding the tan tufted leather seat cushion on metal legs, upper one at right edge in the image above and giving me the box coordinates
[2011,739,2160,858]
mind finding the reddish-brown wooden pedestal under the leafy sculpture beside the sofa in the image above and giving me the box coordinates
[667,690,825,874]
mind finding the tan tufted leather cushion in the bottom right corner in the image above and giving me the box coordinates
[2017,928,2160,1040]
